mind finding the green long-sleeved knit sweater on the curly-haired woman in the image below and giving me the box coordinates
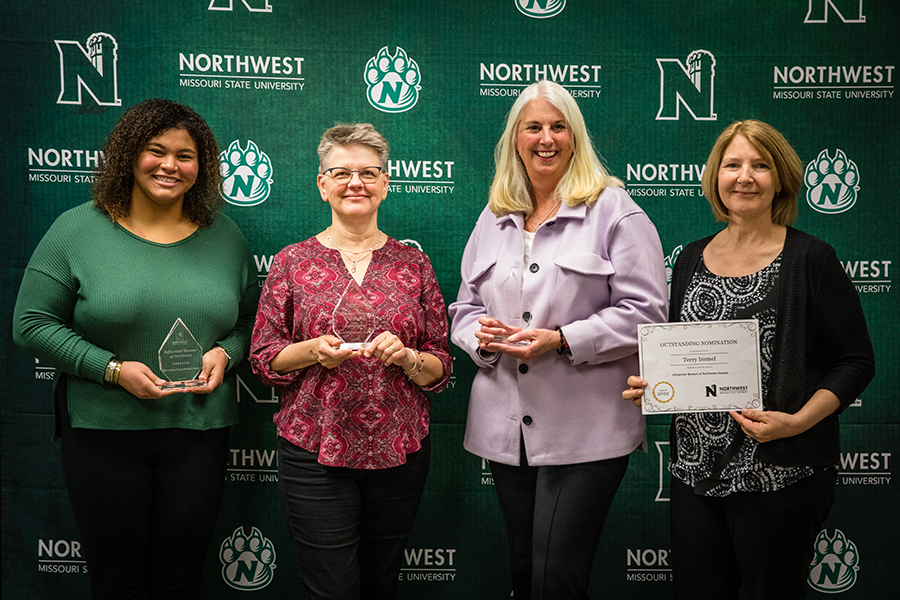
[13,203,259,430]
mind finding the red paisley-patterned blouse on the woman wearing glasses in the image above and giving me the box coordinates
[250,237,451,469]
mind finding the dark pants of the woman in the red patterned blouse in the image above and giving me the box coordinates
[278,437,431,600]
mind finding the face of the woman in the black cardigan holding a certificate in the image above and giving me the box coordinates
[716,135,781,219]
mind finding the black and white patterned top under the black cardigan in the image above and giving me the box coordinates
[669,255,813,497]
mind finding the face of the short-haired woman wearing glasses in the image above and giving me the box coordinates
[317,146,388,224]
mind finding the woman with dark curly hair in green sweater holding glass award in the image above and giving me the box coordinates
[13,100,258,598]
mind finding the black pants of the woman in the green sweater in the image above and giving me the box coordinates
[57,381,228,600]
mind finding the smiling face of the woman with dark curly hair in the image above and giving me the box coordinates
[131,129,200,208]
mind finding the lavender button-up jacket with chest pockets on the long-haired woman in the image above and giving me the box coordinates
[449,187,667,466]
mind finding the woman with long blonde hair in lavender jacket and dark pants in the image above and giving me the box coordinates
[450,81,666,600]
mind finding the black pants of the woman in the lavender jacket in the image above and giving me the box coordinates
[491,440,629,600]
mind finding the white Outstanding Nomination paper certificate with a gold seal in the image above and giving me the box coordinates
[638,319,762,415]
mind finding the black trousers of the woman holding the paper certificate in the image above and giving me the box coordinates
[669,469,837,600]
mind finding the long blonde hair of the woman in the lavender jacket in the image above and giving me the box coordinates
[488,80,624,217]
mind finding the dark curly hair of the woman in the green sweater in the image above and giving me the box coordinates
[91,99,222,227]
